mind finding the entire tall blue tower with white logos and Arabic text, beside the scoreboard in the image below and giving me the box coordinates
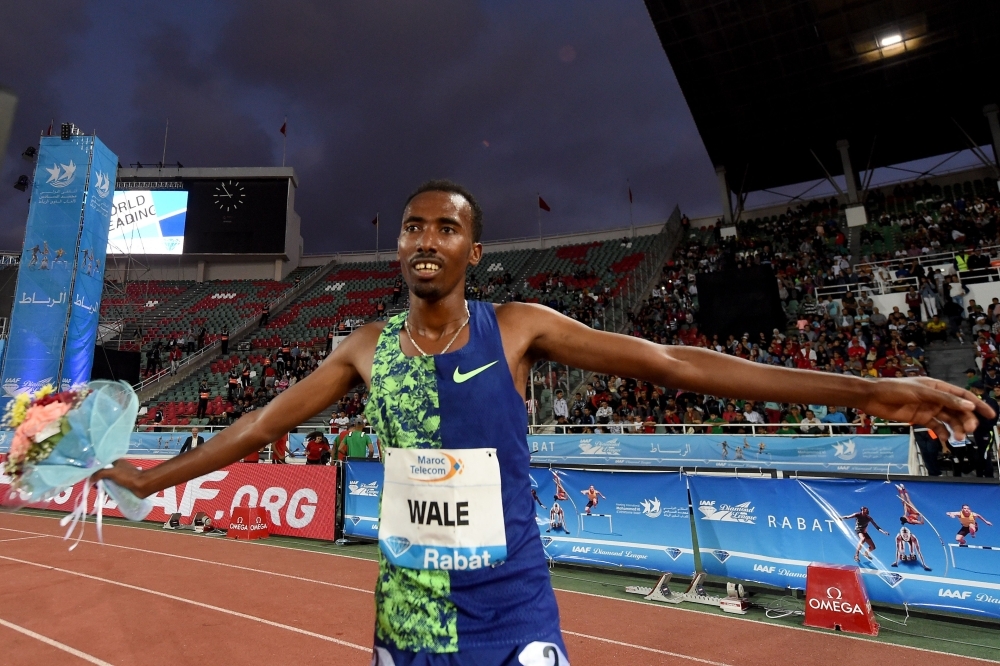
[0,136,118,407]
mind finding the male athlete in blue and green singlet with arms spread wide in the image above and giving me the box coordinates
[95,181,993,666]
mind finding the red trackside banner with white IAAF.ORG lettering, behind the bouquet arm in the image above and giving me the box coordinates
[0,460,337,541]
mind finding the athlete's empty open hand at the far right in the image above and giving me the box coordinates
[858,377,994,442]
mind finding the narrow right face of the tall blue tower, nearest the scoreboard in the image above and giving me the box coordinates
[62,137,118,388]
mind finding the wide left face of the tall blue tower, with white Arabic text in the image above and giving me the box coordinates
[0,136,92,408]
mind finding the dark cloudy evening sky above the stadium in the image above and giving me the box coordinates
[0,0,720,253]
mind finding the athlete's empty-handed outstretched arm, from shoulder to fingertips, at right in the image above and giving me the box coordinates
[502,303,994,441]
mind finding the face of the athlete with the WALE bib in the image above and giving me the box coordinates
[397,192,483,301]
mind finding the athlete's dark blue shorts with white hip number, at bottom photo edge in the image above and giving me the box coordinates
[371,634,569,666]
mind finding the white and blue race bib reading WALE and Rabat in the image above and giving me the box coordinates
[378,449,507,571]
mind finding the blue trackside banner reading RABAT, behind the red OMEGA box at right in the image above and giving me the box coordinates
[688,475,1000,618]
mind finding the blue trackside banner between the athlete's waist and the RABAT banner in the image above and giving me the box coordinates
[531,467,694,573]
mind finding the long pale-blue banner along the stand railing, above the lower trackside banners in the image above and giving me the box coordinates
[528,434,910,474]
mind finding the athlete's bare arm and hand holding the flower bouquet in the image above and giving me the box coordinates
[93,325,381,497]
